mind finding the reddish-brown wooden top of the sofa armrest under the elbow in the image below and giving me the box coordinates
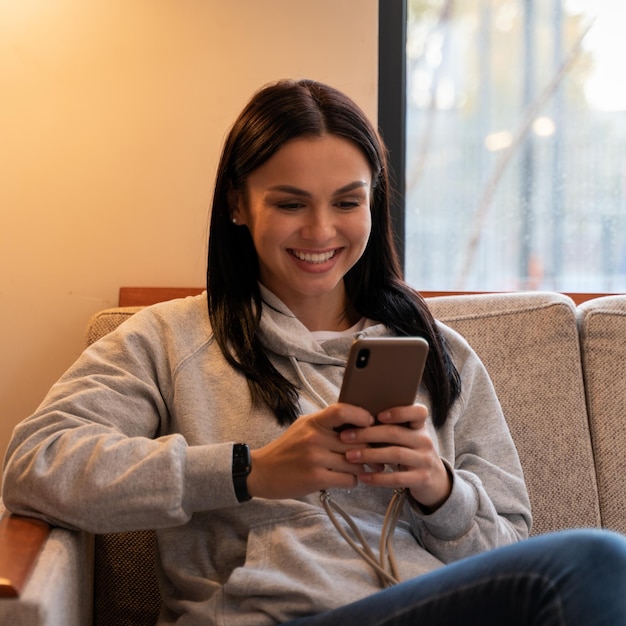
[0,513,50,598]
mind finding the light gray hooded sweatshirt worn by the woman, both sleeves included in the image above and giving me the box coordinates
[3,291,530,626]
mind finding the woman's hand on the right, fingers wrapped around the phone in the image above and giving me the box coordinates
[341,405,452,513]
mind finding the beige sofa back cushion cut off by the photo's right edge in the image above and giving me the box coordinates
[578,295,626,532]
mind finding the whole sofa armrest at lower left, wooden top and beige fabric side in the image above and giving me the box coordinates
[0,503,94,626]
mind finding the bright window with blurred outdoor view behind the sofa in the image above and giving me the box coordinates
[379,0,626,292]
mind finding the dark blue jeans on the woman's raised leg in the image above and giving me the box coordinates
[288,530,626,626]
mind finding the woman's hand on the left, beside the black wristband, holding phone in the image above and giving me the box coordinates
[248,404,374,499]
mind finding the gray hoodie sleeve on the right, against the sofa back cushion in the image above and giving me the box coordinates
[402,329,531,563]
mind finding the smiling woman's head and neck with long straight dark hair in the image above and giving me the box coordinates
[207,80,457,424]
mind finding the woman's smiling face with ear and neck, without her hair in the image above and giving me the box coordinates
[231,135,372,330]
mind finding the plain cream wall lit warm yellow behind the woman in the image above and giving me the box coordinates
[0,0,378,478]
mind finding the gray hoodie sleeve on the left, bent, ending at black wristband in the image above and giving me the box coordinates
[3,304,241,532]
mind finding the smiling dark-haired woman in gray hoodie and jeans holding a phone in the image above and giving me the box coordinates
[3,81,626,626]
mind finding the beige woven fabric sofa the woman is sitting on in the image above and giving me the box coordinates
[0,293,626,626]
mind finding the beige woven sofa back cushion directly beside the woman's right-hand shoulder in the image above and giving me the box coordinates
[428,292,600,534]
